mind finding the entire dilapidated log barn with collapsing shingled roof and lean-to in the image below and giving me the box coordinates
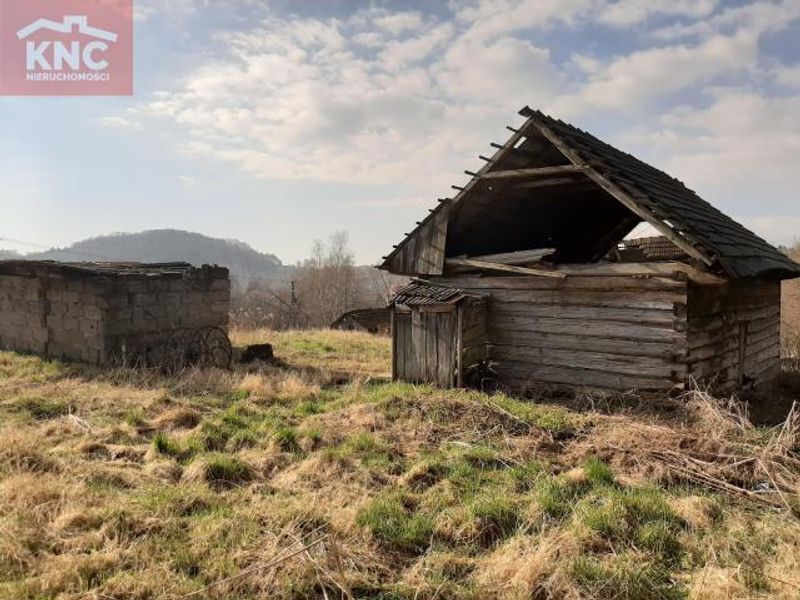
[381,107,800,390]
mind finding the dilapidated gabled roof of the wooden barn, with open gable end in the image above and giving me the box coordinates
[381,107,800,279]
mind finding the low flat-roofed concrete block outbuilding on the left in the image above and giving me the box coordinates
[0,260,230,366]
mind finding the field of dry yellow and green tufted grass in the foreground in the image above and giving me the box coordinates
[0,332,800,600]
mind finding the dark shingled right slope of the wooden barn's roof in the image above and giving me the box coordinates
[520,108,800,279]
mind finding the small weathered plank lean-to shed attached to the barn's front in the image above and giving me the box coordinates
[392,283,486,387]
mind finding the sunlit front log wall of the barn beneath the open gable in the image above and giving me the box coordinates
[435,270,688,390]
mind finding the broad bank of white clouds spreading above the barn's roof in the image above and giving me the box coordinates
[134,0,800,220]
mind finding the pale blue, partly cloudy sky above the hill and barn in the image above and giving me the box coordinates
[0,0,800,262]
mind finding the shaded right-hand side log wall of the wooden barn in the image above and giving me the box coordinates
[687,282,781,388]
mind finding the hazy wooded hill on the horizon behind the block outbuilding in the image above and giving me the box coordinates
[21,229,288,285]
